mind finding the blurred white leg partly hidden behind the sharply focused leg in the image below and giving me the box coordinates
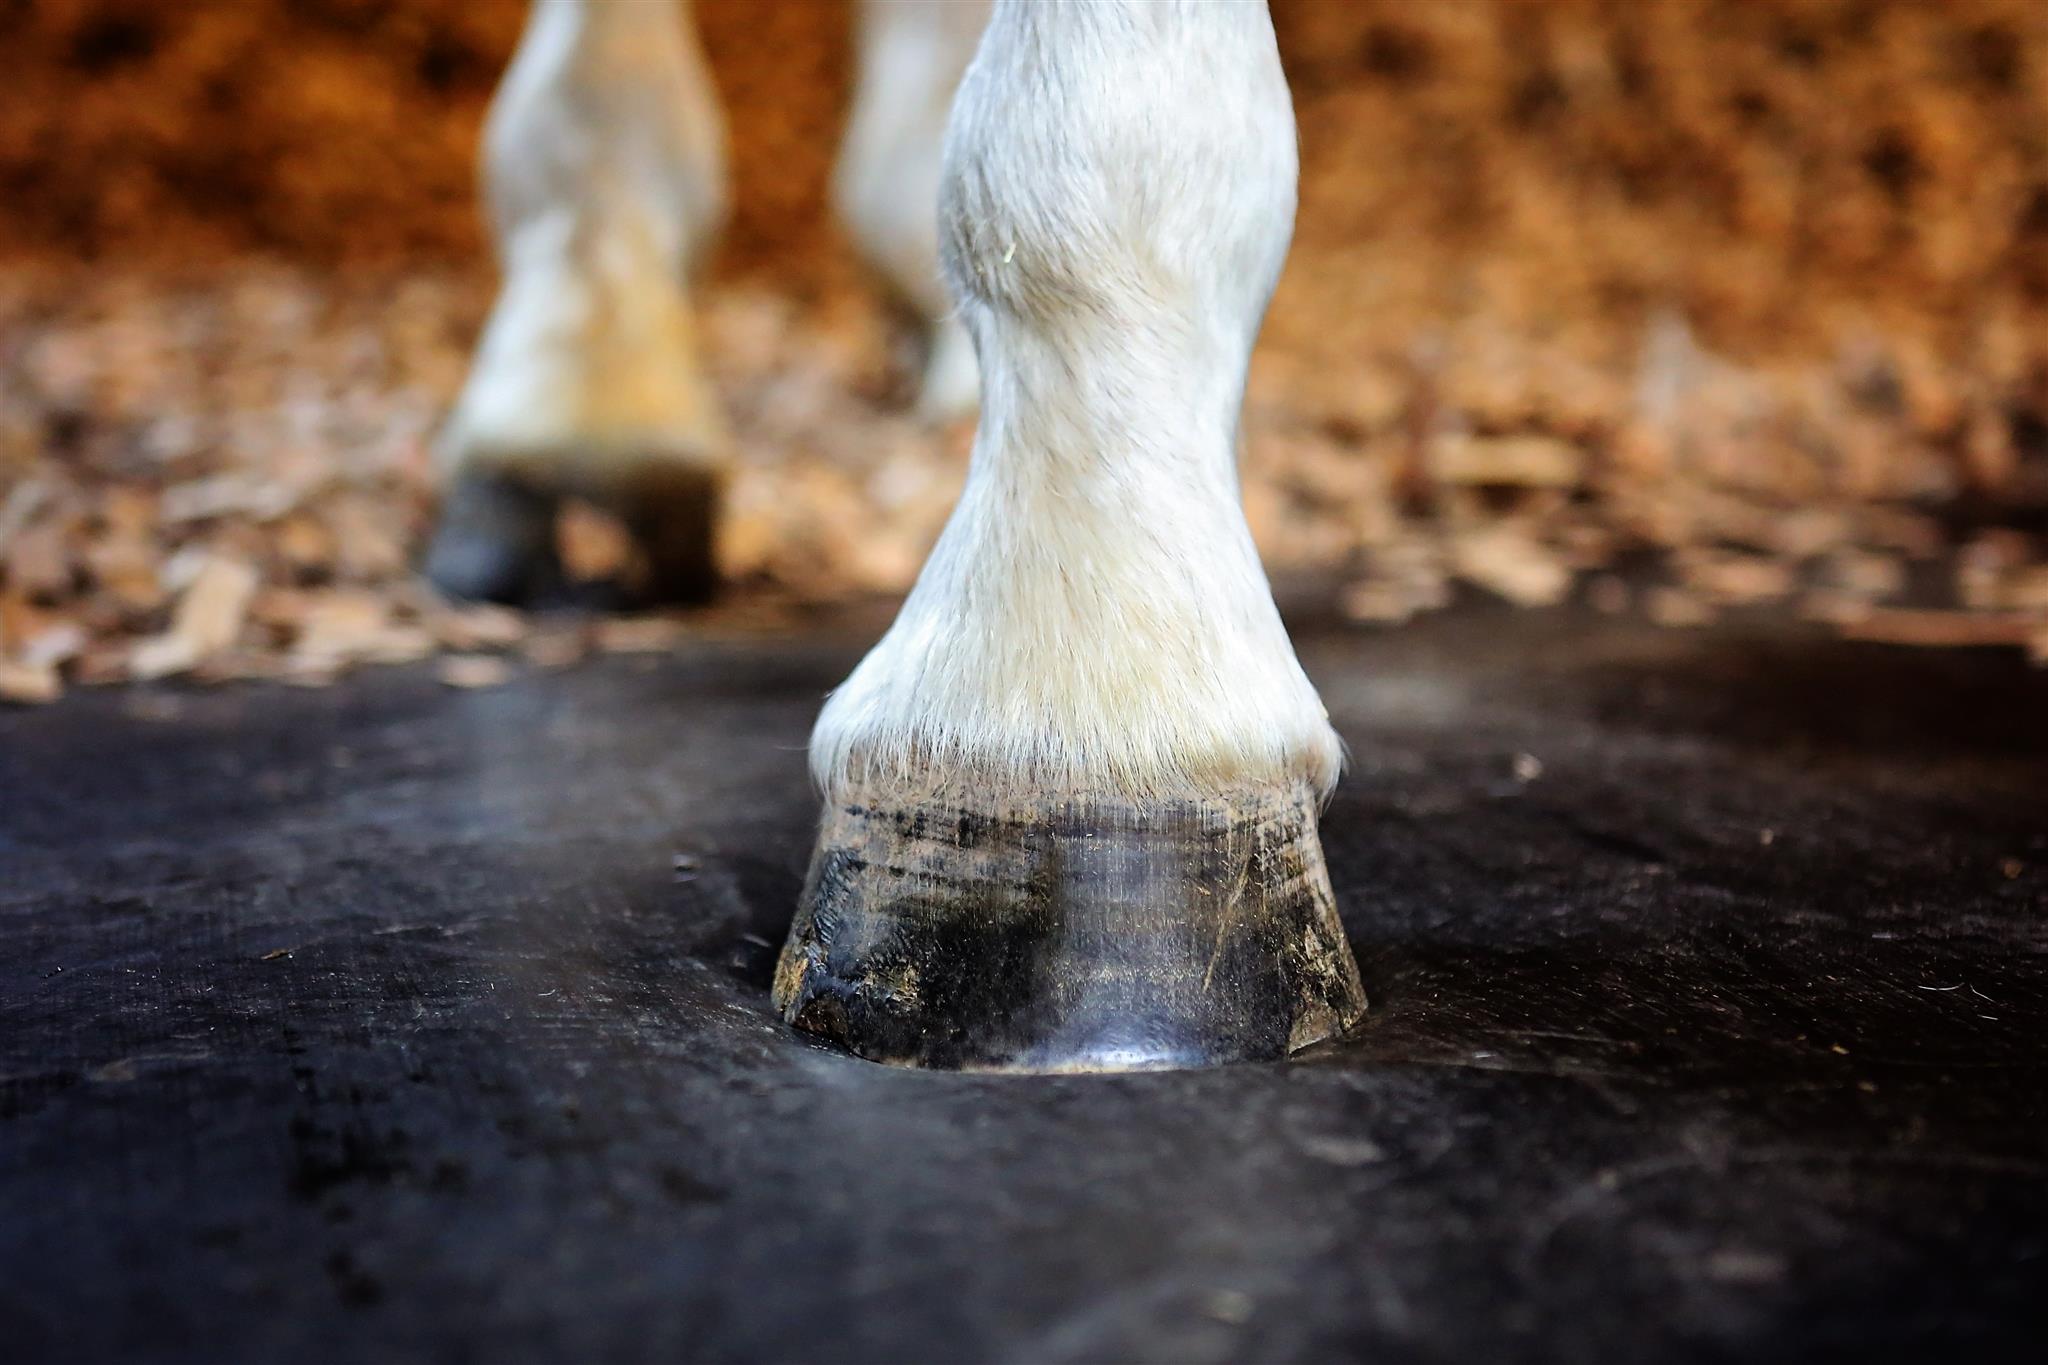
[834,0,989,422]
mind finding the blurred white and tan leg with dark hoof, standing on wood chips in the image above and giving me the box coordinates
[426,0,725,598]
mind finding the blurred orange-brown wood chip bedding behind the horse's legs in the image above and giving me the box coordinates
[0,0,2048,694]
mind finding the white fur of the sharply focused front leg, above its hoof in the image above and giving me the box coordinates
[811,0,1339,798]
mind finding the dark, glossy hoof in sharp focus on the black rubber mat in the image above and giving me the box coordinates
[774,794,1366,1072]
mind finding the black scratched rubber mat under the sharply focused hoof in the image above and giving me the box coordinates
[0,610,2048,1363]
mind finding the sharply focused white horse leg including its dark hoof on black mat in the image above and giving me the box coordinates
[776,0,1364,1070]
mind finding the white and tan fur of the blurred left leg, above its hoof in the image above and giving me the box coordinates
[440,0,725,491]
